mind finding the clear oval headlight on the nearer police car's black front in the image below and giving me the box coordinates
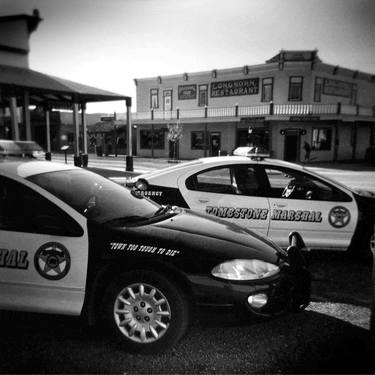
[211,259,280,280]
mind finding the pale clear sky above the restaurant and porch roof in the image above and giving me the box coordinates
[0,0,375,114]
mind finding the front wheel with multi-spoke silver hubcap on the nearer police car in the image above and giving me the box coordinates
[103,270,190,354]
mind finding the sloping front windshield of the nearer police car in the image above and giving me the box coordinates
[28,169,160,224]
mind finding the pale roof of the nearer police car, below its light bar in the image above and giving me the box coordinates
[0,157,77,178]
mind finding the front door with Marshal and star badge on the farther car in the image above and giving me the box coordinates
[264,166,358,250]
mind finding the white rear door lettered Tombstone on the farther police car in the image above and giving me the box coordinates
[178,164,269,235]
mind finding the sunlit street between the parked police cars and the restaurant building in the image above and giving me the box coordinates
[52,154,375,192]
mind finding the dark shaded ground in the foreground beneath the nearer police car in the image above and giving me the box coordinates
[0,311,375,374]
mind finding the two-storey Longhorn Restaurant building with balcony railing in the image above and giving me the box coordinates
[132,50,375,161]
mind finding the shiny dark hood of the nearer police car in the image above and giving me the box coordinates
[134,209,283,263]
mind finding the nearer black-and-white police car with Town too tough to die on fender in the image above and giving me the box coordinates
[0,159,310,352]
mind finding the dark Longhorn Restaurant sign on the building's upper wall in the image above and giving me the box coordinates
[211,78,259,98]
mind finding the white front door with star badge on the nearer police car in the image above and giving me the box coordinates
[0,176,88,315]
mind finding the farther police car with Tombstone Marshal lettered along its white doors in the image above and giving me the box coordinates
[128,148,375,254]
